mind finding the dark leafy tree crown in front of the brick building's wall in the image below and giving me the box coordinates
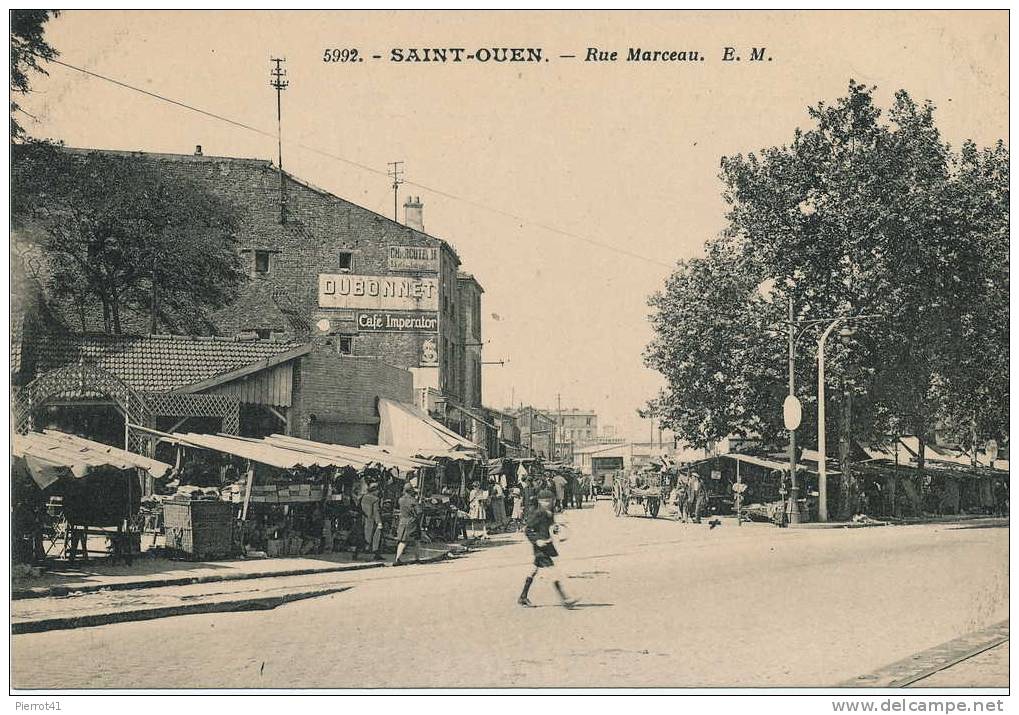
[11,143,245,333]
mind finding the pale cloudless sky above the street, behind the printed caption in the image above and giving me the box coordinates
[21,11,1008,439]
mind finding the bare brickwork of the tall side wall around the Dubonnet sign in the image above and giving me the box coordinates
[38,150,466,397]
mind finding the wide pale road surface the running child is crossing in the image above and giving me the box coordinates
[12,502,1008,688]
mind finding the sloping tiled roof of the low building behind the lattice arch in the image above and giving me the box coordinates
[33,334,303,392]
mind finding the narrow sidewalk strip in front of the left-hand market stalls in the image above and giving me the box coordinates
[11,543,464,601]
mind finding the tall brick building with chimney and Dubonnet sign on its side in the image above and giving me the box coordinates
[33,148,482,415]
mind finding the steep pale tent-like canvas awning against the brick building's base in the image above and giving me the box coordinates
[377,397,482,459]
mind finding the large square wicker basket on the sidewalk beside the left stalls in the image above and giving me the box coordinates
[163,501,233,559]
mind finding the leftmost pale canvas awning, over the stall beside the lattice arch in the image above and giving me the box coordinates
[11,430,172,489]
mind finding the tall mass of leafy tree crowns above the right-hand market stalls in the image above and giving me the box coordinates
[648,81,1008,512]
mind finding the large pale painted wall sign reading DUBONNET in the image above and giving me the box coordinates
[319,273,439,312]
